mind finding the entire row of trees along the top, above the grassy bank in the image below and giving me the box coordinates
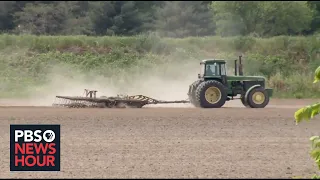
[0,1,320,37]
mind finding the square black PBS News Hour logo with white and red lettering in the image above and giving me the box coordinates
[10,124,60,171]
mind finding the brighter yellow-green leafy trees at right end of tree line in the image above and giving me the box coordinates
[211,1,313,36]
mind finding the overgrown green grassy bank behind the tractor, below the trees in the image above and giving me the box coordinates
[0,33,320,98]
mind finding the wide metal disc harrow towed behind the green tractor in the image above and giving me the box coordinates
[52,89,189,108]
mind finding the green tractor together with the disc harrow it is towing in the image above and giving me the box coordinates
[53,56,273,108]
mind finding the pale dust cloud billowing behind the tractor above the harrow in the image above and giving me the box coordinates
[1,61,200,107]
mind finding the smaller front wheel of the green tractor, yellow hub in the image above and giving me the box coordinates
[247,87,270,108]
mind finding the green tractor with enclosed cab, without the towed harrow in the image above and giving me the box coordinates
[188,56,273,108]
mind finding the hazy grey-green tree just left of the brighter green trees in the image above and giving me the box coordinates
[155,1,214,37]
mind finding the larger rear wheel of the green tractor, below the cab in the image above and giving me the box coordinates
[196,80,227,108]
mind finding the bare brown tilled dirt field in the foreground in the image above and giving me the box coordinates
[0,100,320,178]
